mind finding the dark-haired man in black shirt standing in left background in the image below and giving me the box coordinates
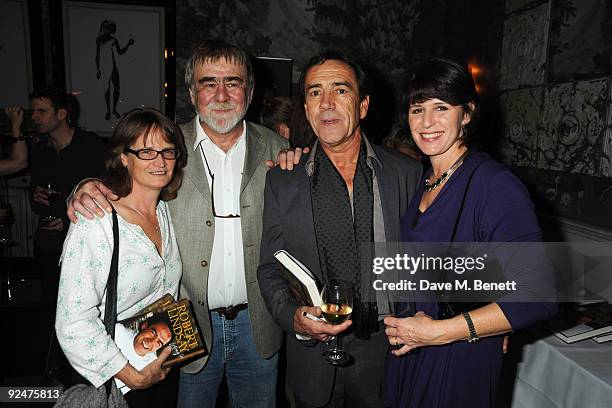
[29,88,104,346]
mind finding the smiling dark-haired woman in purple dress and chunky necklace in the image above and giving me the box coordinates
[385,59,557,408]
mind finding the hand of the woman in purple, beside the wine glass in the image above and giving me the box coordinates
[385,312,446,356]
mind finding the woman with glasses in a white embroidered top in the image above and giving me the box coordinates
[55,109,187,407]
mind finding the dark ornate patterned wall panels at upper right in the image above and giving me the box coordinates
[500,0,612,228]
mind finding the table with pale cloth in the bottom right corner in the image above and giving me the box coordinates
[510,332,612,408]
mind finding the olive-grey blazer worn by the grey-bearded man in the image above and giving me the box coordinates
[168,119,288,373]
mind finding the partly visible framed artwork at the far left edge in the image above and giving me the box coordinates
[0,0,33,108]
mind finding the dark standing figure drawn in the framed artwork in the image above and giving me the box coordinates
[96,20,134,120]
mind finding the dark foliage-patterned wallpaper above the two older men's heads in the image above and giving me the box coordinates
[176,0,445,133]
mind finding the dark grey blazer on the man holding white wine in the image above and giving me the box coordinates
[257,145,422,405]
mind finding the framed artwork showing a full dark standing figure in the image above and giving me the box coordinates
[62,1,166,136]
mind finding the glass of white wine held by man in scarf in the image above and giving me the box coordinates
[321,281,353,365]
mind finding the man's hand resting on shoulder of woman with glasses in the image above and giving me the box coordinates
[66,179,119,224]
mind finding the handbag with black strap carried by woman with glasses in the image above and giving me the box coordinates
[52,208,128,408]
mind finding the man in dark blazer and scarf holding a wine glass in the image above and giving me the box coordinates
[258,51,421,407]
